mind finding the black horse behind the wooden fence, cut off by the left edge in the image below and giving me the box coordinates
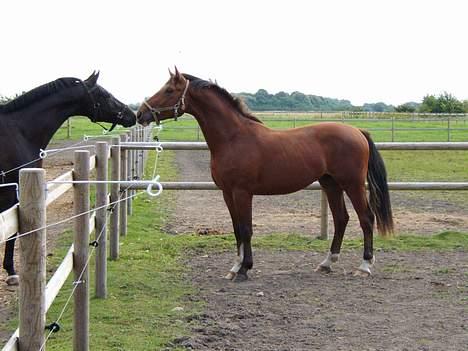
[0,73,136,285]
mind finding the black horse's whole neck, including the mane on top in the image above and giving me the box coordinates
[0,85,90,149]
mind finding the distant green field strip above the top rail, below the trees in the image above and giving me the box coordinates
[54,112,468,141]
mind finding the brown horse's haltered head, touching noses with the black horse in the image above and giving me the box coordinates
[137,67,189,126]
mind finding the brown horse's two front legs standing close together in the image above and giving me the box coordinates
[223,190,253,281]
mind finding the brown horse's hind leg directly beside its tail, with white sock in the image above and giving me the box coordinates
[345,184,375,276]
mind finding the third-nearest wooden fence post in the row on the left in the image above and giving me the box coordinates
[95,141,109,298]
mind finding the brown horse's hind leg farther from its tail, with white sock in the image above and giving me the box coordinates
[315,175,349,273]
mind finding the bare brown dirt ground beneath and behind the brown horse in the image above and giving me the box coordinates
[165,152,468,350]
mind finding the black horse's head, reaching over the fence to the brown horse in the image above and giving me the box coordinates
[83,72,136,130]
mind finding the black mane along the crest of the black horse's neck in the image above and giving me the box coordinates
[0,78,79,112]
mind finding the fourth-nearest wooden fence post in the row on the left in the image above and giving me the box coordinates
[109,136,120,260]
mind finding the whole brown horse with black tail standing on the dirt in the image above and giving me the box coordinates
[137,68,393,280]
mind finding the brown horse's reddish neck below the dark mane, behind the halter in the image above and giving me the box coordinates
[187,90,245,152]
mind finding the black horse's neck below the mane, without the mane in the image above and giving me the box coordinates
[11,96,85,149]
